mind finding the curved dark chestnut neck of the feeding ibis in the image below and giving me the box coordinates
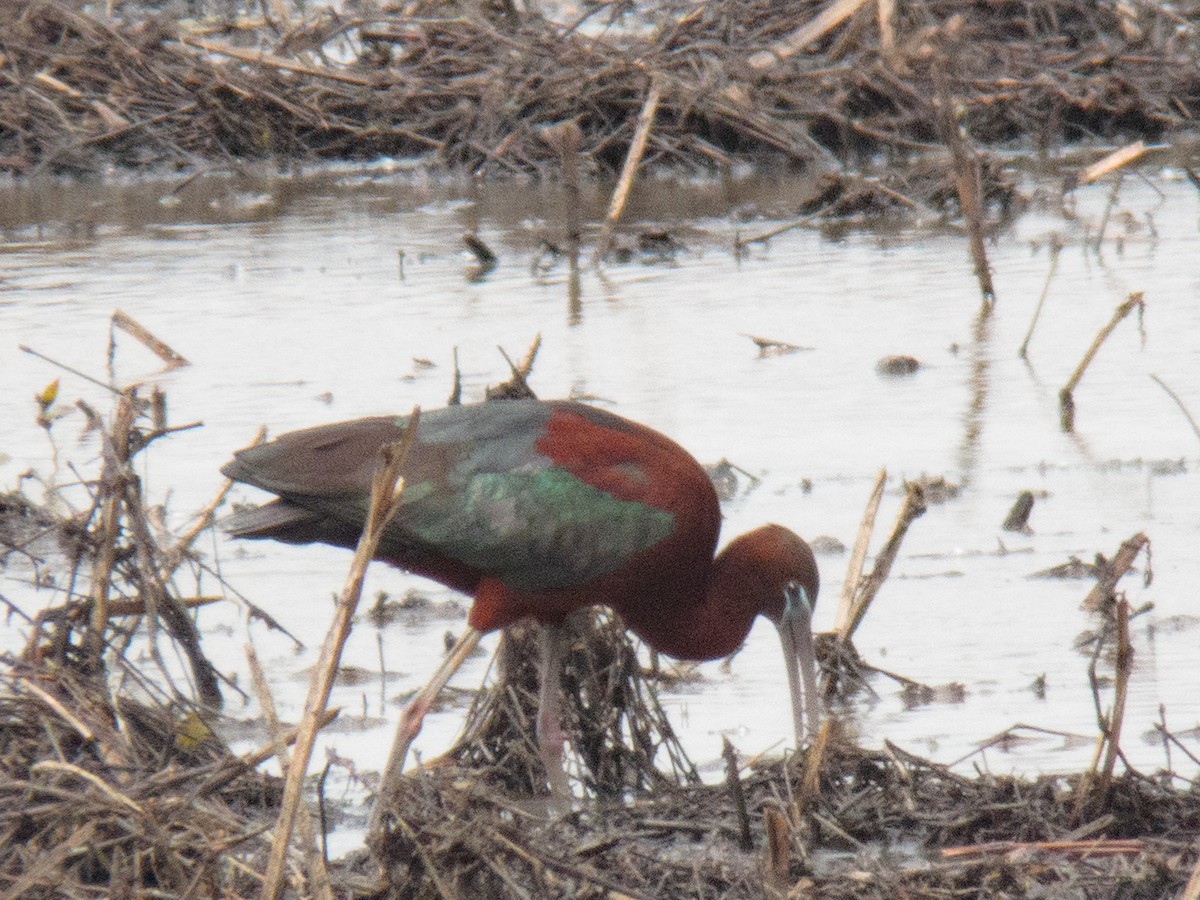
[620,553,763,660]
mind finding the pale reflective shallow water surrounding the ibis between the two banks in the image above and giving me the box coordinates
[0,172,1200,854]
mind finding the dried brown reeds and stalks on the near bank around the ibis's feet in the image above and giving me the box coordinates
[0,326,1200,899]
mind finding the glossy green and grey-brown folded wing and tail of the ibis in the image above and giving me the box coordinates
[222,401,674,590]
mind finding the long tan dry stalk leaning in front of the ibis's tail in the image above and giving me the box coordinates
[259,408,420,900]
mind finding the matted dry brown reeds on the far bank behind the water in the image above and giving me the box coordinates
[0,0,1200,183]
